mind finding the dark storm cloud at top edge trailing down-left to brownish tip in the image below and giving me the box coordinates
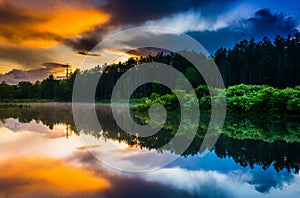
[63,0,234,51]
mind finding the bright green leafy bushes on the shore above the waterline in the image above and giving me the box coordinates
[137,84,300,114]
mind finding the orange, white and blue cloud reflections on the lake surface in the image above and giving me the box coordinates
[0,119,300,197]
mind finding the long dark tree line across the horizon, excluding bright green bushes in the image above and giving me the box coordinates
[0,32,300,101]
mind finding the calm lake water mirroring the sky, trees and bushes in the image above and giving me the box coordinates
[0,104,300,197]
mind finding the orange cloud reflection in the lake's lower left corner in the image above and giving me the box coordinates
[0,158,110,197]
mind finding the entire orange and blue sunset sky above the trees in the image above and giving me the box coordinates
[0,0,300,84]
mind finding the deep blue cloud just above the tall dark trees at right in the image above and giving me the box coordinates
[188,8,297,53]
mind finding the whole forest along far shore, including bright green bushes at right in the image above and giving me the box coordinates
[0,32,300,112]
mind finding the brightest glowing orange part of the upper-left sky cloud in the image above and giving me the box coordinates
[0,9,110,48]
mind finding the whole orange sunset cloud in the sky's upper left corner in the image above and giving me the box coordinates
[0,2,110,48]
